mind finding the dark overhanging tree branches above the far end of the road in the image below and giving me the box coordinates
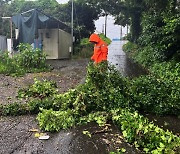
[85,0,144,42]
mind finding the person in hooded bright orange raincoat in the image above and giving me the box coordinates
[89,33,108,64]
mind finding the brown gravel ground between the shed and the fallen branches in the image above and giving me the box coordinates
[0,59,88,104]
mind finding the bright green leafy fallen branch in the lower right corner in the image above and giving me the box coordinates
[112,109,180,154]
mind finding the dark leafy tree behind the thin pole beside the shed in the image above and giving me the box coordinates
[56,0,100,40]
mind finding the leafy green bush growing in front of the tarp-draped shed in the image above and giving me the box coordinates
[0,44,49,76]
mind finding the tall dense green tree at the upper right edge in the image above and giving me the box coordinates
[139,0,180,60]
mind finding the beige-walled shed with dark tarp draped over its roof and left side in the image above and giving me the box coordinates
[12,9,72,59]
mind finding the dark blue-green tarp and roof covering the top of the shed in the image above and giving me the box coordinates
[12,9,70,44]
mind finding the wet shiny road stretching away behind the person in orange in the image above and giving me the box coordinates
[108,41,147,77]
